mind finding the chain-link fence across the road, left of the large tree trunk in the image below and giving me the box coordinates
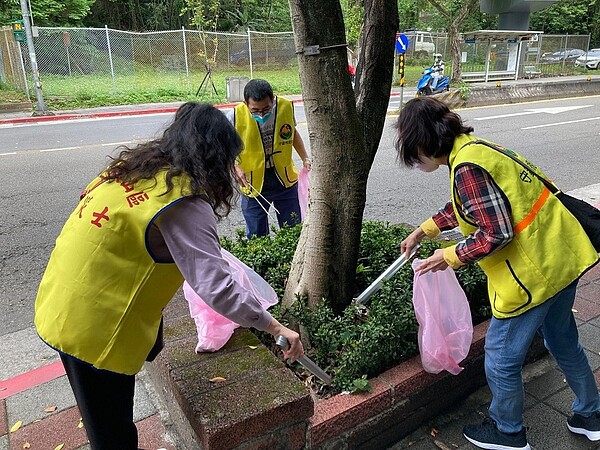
[10,27,297,102]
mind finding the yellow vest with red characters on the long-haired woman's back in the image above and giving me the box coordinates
[35,171,189,375]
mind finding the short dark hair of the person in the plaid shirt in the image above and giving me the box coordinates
[395,97,473,167]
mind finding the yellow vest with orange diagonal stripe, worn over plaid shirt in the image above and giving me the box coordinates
[449,135,598,318]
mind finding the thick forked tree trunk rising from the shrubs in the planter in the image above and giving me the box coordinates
[283,0,398,312]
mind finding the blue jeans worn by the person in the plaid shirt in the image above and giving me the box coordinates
[485,281,600,433]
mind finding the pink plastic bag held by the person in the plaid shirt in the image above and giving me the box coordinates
[412,259,473,375]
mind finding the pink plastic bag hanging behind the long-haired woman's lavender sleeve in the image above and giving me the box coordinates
[183,250,277,353]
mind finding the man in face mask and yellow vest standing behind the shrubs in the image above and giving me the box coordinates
[229,79,311,238]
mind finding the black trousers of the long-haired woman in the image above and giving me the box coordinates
[60,353,138,450]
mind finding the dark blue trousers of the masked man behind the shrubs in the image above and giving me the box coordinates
[242,168,300,239]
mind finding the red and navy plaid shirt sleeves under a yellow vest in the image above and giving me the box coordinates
[433,164,515,264]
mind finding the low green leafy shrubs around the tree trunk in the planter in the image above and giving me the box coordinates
[222,222,490,392]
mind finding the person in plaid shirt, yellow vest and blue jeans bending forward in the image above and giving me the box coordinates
[396,97,600,450]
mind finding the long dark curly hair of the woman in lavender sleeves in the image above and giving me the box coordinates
[103,102,242,219]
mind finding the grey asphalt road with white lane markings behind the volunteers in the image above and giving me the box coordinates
[0,97,600,336]
